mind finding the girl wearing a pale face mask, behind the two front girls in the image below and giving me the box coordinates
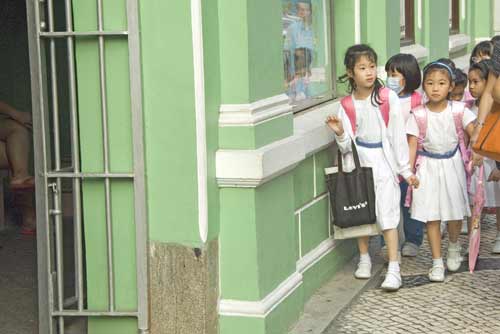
[385,53,424,256]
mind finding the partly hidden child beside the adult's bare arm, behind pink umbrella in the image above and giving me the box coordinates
[469,62,500,254]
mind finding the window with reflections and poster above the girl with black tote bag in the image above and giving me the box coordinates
[282,0,334,111]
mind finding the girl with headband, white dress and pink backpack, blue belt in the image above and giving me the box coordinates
[407,62,475,282]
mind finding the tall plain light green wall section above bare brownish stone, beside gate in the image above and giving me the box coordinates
[140,0,201,245]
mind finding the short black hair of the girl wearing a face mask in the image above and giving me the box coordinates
[385,53,422,94]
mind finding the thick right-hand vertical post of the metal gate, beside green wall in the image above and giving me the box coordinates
[127,0,149,334]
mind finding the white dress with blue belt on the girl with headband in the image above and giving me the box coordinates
[406,104,476,222]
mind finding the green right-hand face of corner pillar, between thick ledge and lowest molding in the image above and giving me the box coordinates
[255,173,297,298]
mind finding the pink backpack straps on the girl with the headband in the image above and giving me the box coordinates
[405,101,471,207]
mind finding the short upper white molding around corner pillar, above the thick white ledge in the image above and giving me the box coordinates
[219,94,293,127]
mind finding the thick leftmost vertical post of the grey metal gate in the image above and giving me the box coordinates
[26,1,54,334]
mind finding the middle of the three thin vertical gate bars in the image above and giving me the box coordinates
[61,0,83,316]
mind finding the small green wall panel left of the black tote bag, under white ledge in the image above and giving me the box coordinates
[293,157,314,209]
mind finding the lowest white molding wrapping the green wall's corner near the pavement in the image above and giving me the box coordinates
[219,238,339,318]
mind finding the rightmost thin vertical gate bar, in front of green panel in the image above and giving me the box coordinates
[97,0,115,312]
